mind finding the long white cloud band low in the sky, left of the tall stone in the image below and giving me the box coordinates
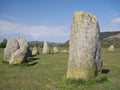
[0,20,69,40]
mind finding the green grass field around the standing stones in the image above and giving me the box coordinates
[0,48,120,90]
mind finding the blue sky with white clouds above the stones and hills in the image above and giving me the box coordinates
[0,0,120,42]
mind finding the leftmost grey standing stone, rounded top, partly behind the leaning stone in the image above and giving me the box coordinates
[3,39,19,62]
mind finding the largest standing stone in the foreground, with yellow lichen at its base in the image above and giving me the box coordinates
[67,11,102,79]
